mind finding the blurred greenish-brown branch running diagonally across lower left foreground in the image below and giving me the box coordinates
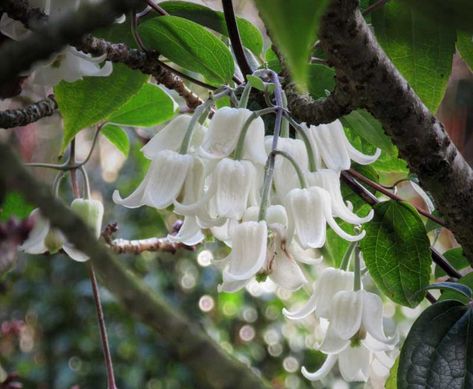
[0,143,270,388]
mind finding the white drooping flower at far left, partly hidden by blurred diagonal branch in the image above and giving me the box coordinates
[18,199,104,262]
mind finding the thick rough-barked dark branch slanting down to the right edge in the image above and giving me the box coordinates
[293,0,473,264]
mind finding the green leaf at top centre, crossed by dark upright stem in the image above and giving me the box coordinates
[159,1,263,56]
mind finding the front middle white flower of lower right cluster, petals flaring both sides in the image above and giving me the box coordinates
[320,289,396,354]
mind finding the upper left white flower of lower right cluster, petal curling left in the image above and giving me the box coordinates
[283,267,354,320]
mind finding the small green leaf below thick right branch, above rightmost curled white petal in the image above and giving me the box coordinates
[340,109,395,155]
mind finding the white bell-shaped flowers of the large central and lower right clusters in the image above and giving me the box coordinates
[113,101,395,381]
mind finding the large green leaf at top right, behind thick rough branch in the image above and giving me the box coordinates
[372,1,456,112]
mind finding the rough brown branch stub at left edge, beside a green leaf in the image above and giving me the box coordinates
[0,95,57,129]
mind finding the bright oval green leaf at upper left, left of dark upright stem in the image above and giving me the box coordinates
[138,16,235,84]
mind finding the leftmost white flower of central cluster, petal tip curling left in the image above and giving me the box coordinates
[113,150,193,209]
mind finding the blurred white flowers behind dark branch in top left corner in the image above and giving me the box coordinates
[0,0,113,88]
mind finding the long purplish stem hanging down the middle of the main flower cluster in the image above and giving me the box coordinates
[258,70,284,220]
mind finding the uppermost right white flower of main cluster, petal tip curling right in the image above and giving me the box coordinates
[307,120,381,170]
